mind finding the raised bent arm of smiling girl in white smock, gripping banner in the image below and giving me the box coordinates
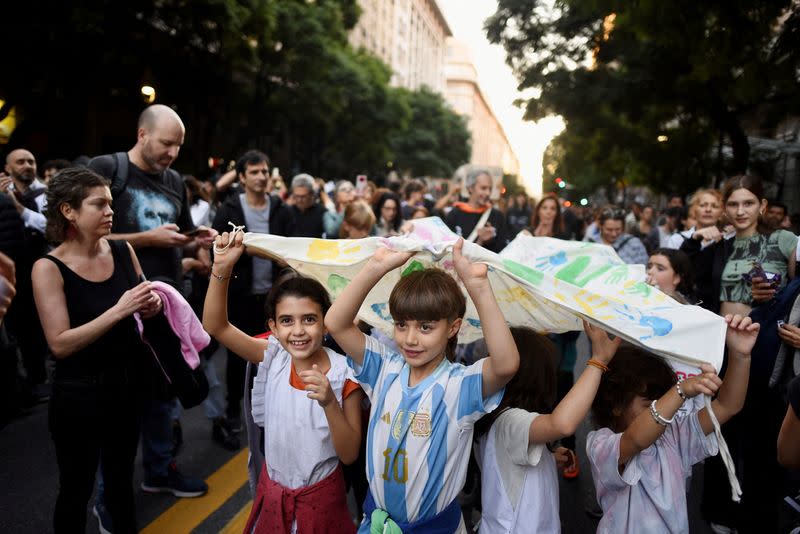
[203,232,267,363]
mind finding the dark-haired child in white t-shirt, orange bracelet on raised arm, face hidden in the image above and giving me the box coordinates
[476,323,620,533]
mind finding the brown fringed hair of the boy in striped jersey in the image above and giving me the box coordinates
[389,269,467,361]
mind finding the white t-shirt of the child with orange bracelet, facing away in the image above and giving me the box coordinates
[476,408,561,534]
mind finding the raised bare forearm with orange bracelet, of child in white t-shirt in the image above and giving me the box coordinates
[528,321,622,443]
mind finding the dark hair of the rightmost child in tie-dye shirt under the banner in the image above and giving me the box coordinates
[592,344,676,432]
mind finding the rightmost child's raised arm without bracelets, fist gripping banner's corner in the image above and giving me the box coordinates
[697,315,760,434]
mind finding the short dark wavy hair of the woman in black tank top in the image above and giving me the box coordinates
[44,167,111,243]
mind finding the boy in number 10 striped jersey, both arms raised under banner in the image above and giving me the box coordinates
[325,240,519,533]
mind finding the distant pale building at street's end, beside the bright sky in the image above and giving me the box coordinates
[445,38,519,175]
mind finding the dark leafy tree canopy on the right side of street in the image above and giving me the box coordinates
[486,0,798,190]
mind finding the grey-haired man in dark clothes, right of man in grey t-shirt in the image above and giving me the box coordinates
[272,174,326,238]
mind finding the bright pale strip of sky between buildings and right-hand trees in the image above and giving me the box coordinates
[437,0,563,196]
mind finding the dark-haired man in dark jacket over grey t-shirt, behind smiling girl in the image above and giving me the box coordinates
[212,150,281,432]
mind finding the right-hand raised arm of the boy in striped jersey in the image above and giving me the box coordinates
[453,239,519,398]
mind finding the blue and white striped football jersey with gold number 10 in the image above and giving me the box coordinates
[347,336,503,531]
